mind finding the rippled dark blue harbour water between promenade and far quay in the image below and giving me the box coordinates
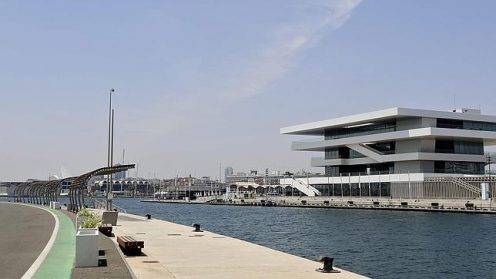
[4,199,496,278]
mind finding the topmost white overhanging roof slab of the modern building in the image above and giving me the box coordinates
[280,107,496,134]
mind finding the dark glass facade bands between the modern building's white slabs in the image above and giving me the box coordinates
[318,117,496,178]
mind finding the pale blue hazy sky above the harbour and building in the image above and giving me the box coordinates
[0,0,496,181]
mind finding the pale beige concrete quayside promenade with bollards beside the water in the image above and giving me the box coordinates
[108,213,366,279]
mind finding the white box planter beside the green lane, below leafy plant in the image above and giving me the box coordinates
[76,228,99,267]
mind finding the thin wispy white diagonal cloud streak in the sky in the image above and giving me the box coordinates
[128,0,361,133]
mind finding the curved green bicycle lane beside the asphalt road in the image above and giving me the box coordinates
[33,208,76,279]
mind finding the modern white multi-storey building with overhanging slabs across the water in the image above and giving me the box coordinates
[281,108,496,198]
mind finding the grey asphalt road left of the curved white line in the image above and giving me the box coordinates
[0,203,55,278]
